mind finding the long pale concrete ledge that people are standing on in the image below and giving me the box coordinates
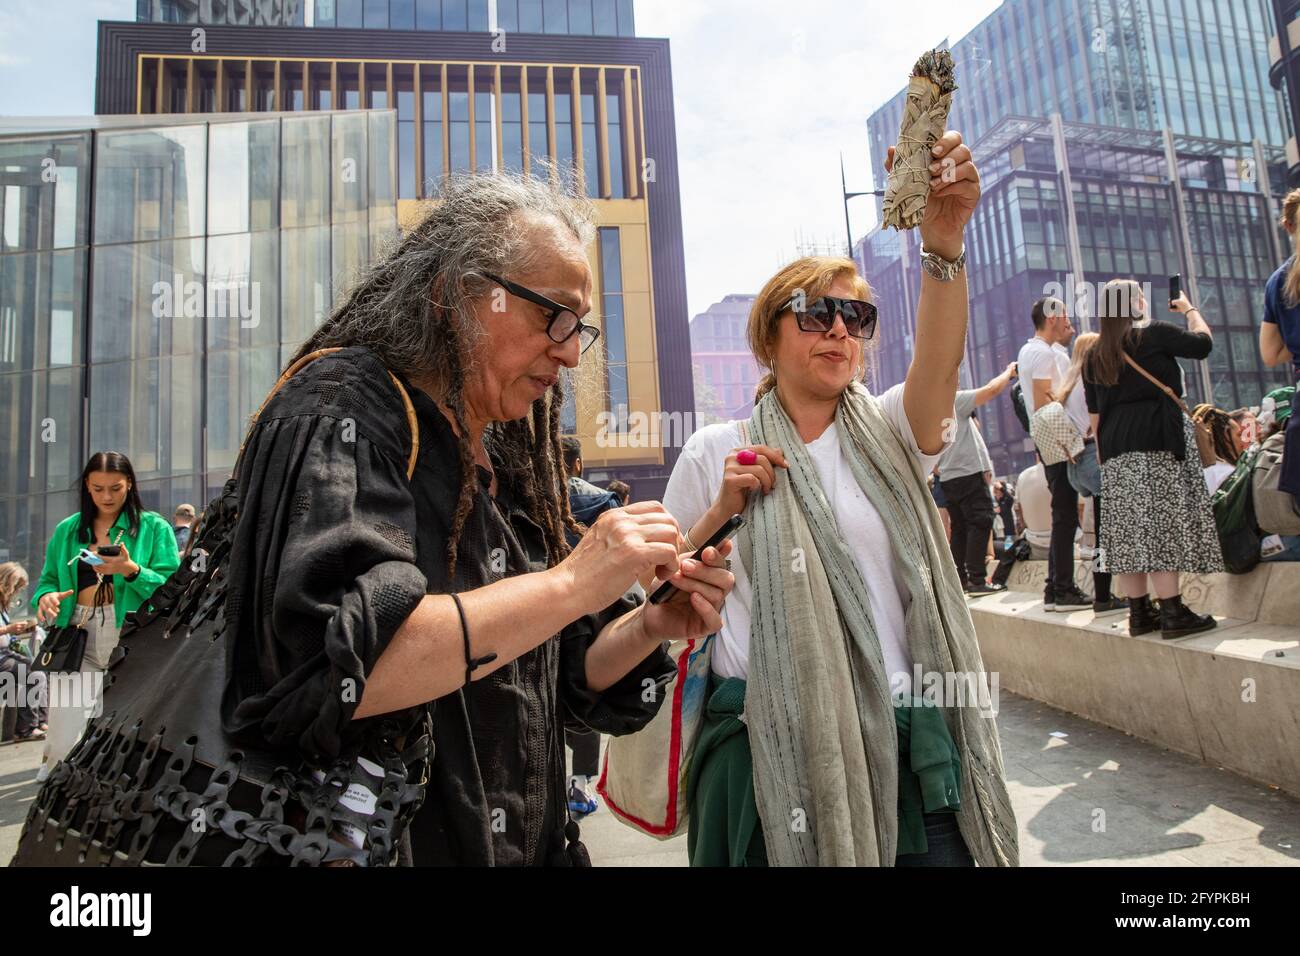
[970,562,1300,796]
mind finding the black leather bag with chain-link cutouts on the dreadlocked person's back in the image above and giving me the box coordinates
[13,349,432,866]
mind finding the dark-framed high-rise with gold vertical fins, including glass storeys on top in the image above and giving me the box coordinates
[95,0,693,498]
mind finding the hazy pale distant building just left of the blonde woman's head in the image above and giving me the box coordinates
[690,295,761,420]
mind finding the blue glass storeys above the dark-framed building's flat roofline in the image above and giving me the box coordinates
[135,0,636,36]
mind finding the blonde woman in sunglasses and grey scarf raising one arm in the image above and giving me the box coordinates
[664,131,1018,866]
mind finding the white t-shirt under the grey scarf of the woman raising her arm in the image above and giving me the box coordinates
[663,385,939,693]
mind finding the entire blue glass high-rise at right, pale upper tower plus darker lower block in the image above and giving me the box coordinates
[854,0,1290,473]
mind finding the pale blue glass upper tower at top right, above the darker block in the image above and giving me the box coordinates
[867,0,1291,180]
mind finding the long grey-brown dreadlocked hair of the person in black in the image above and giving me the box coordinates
[289,170,594,576]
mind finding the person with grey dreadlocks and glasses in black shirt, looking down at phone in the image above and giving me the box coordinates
[189,176,733,865]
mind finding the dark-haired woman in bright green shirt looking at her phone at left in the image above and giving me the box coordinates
[31,451,181,780]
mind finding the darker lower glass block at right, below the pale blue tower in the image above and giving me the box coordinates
[855,118,1287,475]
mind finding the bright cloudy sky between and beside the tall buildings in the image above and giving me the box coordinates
[0,0,1001,315]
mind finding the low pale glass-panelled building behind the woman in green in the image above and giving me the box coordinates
[0,111,397,580]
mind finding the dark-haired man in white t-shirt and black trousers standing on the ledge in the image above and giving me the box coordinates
[1017,298,1092,611]
